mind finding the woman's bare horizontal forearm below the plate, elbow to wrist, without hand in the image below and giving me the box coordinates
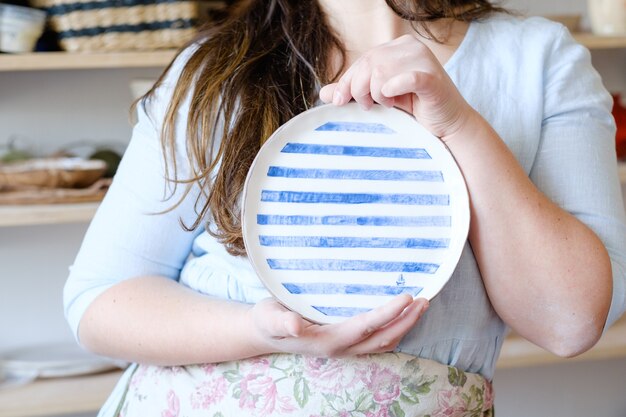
[79,276,267,365]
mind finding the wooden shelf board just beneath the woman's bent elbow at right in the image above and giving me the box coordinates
[496,316,626,369]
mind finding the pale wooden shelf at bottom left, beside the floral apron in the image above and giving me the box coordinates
[0,371,122,417]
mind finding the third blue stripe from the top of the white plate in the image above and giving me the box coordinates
[267,166,443,182]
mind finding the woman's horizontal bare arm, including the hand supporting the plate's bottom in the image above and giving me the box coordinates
[79,277,428,366]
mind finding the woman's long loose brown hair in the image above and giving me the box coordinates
[144,0,502,255]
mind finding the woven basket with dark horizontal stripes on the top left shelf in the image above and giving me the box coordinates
[33,0,199,52]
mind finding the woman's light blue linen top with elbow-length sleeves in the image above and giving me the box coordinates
[64,15,626,390]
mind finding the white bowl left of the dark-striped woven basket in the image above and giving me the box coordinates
[0,4,46,53]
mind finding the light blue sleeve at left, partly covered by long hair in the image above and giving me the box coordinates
[63,48,200,337]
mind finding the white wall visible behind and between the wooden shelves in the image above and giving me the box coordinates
[0,0,626,417]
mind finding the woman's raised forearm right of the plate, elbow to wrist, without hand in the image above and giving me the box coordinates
[443,114,612,356]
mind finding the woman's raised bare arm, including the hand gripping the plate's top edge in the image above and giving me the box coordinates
[320,36,612,356]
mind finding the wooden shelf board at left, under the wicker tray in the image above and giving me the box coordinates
[0,203,99,227]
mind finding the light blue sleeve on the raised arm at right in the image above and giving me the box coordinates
[530,28,626,328]
